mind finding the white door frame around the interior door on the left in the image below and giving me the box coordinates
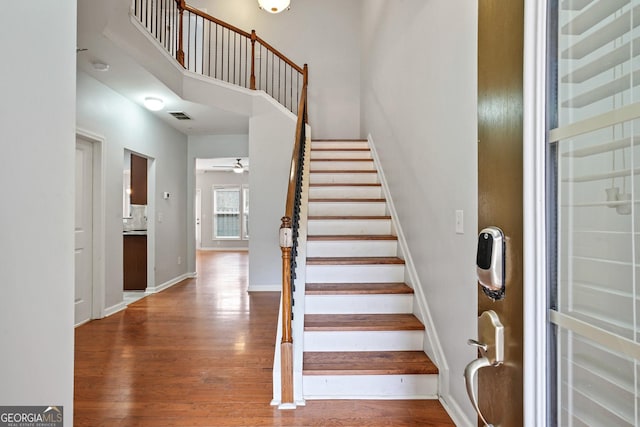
[76,128,106,319]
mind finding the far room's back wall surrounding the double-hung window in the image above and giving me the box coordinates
[196,171,251,249]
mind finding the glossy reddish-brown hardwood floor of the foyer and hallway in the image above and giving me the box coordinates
[74,252,454,427]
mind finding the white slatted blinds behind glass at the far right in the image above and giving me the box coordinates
[549,0,640,427]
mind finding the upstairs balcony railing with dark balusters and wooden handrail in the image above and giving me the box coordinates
[133,0,304,114]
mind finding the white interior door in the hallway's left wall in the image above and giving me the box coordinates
[75,138,93,325]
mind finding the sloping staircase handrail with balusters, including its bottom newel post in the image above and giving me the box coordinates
[280,68,308,404]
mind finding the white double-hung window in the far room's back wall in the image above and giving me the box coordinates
[213,186,249,240]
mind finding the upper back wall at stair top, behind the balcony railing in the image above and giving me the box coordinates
[187,0,361,138]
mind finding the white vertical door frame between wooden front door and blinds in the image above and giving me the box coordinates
[523,0,549,427]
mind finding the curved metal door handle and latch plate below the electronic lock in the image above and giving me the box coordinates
[464,310,504,427]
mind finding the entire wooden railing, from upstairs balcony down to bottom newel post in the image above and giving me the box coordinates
[133,0,308,404]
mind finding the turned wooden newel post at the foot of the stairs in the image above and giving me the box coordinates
[280,216,293,404]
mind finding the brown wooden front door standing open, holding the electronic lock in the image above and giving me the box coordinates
[478,0,524,427]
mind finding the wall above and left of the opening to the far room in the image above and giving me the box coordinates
[186,135,251,272]
